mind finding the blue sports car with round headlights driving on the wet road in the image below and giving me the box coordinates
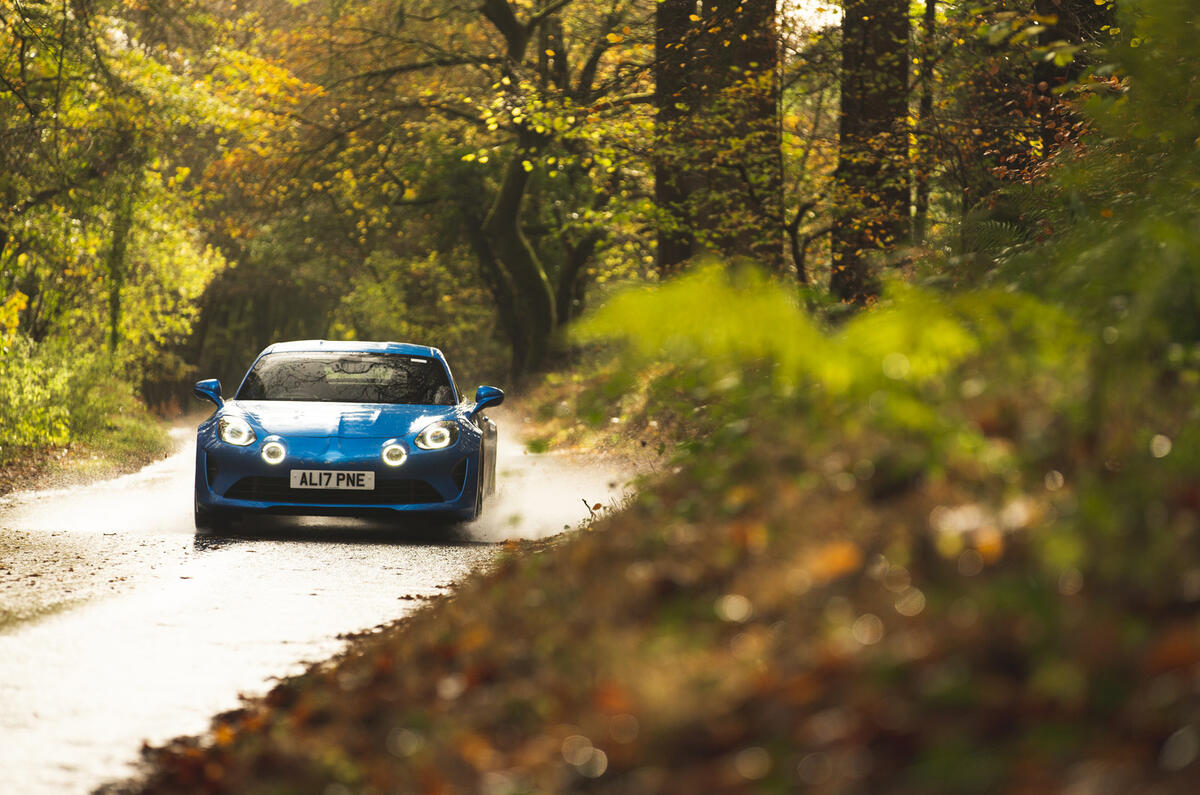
[194,340,504,530]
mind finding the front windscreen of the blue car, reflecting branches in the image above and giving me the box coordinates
[238,352,454,406]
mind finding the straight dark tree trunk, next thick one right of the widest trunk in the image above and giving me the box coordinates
[829,0,910,304]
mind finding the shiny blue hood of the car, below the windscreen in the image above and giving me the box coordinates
[230,400,455,438]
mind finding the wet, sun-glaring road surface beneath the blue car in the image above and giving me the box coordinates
[0,420,624,793]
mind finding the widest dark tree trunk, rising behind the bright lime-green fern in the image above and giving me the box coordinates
[654,0,787,274]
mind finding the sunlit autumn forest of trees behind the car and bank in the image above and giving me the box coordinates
[0,0,1152,456]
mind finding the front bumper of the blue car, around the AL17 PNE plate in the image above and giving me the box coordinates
[196,424,480,519]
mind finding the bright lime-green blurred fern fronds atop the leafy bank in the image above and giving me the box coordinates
[575,264,1086,442]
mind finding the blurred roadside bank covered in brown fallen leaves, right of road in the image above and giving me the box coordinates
[104,357,1200,794]
